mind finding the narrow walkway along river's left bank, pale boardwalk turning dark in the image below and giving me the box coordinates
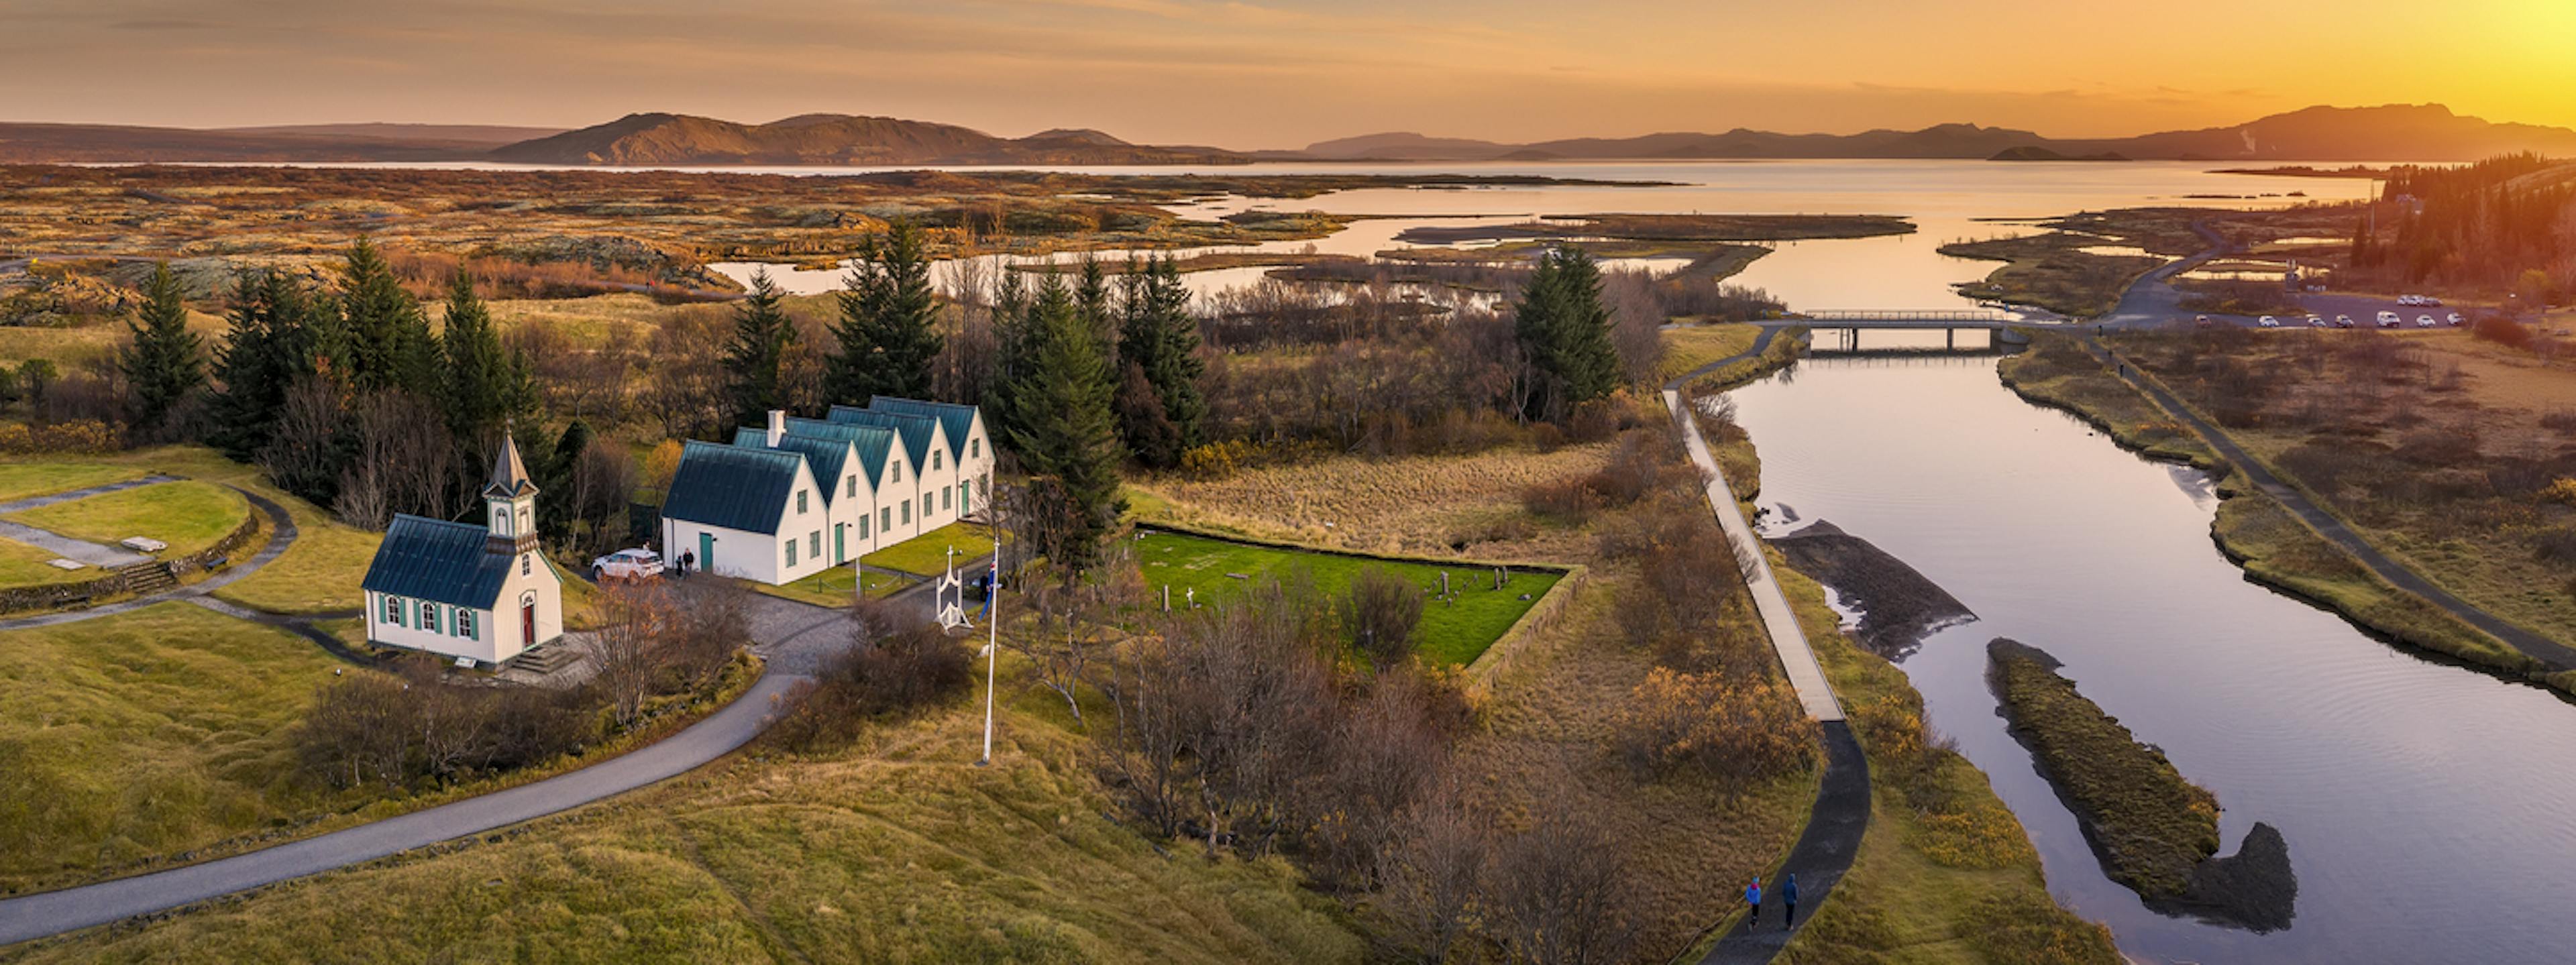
[1664,327,1870,965]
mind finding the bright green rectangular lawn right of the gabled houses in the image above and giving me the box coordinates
[1136,532,1558,664]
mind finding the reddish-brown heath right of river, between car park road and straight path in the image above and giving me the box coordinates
[2117,329,2576,664]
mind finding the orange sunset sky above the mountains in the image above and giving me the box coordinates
[0,0,2576,150]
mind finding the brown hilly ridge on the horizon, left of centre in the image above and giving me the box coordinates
[492,113,1244,165]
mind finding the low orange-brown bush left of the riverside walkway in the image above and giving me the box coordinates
[1615,667,1816,785]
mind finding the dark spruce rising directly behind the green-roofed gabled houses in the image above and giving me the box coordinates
[824,221,941,404]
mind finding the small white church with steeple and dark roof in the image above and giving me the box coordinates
[361,437,564,664]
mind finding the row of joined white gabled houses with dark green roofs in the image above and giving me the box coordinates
[662,396,994,584]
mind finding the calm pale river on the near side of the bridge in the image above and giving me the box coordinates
[1733,357,2576,962]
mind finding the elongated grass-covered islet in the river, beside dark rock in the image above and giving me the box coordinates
[1986,640,2218,898]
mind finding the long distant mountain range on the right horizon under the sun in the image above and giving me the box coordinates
[1298,103,2576,162]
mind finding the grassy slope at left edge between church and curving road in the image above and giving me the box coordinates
[0,602,358,888]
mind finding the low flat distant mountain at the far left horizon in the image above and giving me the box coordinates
[0,123,543,165]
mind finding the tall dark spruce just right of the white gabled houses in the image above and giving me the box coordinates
[1012,278,1126,571]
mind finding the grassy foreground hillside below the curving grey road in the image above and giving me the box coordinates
[0,667,1365,962]
